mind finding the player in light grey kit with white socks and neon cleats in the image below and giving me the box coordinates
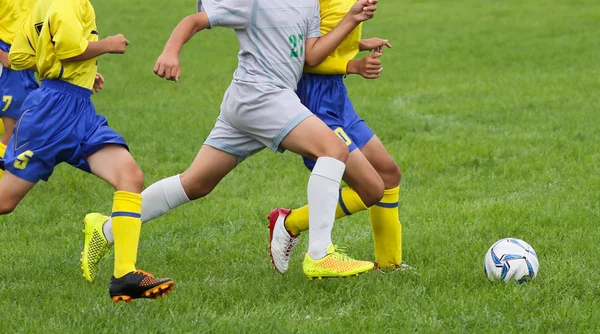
[82,0,377,279]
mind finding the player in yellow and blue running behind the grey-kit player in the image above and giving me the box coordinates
[268,0,402,273]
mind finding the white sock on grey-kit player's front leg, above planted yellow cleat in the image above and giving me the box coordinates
[308,157,346,260]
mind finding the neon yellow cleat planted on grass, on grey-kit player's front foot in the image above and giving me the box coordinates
[303,245,374,280]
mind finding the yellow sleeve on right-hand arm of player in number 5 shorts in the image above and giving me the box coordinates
[48,0,89,60]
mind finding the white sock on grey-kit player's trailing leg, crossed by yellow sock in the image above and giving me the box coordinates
[102,174,190,243]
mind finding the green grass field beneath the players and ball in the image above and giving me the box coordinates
[0,0,600,333]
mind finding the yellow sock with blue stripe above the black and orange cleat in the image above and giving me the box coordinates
[111,191,142,278]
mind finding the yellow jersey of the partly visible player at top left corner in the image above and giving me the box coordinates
[0,0,37,45]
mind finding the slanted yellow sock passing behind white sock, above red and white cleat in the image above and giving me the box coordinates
[285,187,367,235]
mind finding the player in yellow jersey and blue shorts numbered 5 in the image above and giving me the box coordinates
[0,0,174,302]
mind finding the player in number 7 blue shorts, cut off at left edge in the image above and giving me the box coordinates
[0,0,38,178]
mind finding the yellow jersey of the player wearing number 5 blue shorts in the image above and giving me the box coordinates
[9,0,98,89]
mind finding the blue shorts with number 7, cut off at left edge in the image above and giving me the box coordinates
[0,41,39,119]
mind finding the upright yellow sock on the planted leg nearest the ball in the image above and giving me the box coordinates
[369,187,402,269]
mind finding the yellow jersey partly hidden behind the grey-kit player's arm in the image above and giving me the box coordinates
[304,0,362,74]
